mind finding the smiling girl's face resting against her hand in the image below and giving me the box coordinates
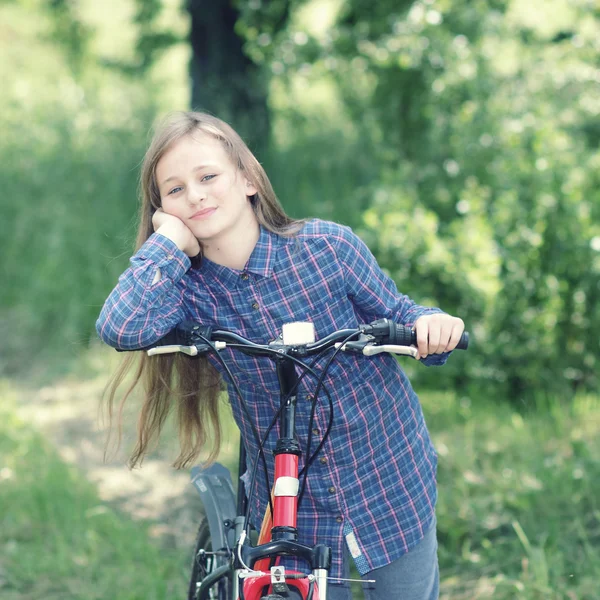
[156,132,256,243]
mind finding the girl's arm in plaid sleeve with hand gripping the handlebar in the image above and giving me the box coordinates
[334,226,464,365]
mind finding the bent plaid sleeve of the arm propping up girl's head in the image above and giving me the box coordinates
[96,233,191,350]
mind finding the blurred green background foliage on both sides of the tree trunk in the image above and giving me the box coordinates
[0,0,600,403]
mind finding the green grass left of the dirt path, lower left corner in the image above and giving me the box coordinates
[0,390,191,600]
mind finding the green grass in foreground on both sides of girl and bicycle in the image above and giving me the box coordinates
[0,372,600,600]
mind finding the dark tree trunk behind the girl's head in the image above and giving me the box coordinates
[187,0,269,160]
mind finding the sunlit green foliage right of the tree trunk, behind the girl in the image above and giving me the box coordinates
[243,0,600,403]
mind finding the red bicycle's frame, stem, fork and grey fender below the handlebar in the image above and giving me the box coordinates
[192,355,331,600]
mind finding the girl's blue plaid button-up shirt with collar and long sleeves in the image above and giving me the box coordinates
[97,220,447,577]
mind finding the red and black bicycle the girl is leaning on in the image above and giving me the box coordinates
[145,319,469,600]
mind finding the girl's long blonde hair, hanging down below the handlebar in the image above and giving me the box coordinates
[106,112,304,469]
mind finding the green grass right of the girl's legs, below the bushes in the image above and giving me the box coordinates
[424,394,600,600]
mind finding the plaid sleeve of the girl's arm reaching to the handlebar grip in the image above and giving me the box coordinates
[335,226,450,366]
